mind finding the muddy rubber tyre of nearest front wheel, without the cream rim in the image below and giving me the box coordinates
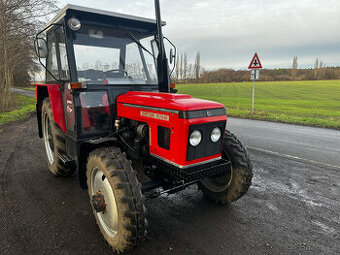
[87,147,147,253]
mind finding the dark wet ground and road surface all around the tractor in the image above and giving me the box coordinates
[0,89,340,255]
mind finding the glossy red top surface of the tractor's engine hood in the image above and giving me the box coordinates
[117,91,224,111]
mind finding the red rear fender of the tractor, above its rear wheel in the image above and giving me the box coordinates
[35,84,66,132]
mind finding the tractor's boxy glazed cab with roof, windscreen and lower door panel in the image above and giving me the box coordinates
[37,5,174,138]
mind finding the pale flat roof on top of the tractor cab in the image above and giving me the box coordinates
[46,4,166,27]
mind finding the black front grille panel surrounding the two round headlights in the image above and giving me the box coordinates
[187,121,226,161]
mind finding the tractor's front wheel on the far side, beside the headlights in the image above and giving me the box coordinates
[198,130,253,204]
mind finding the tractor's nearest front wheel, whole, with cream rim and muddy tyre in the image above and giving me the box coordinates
[86,147,147,253]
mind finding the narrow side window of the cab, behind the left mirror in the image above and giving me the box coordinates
[46,26,70,81]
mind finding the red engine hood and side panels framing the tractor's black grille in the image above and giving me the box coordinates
[117,92,227,166]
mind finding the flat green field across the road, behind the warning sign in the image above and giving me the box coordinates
[176,80,340,129]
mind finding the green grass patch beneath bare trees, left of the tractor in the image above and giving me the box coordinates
[0,94,36,126]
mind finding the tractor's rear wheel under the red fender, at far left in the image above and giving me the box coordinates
[41,97,74,177]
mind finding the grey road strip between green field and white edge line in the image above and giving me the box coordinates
[227,118,340,170]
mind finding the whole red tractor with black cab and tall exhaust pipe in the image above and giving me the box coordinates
[35,0,252,253]
